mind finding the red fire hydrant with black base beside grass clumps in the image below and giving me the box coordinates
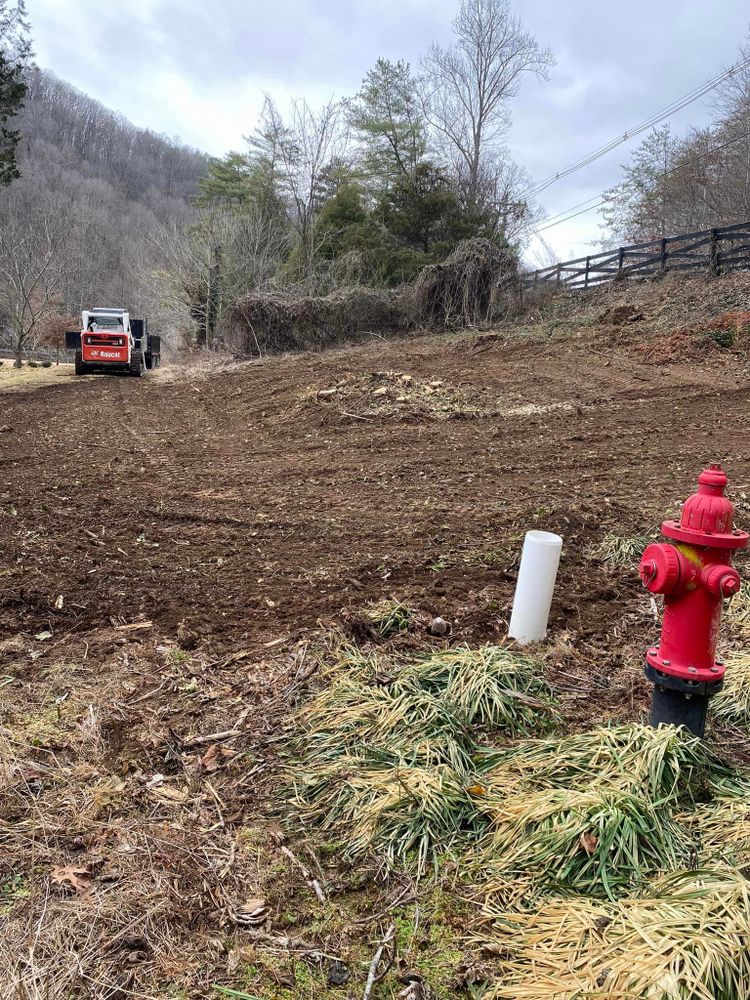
[640,465,750,736]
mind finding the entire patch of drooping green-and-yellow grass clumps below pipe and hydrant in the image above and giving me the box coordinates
[294,606,750,1000]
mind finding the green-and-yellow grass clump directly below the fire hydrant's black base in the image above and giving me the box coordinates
[472,725,750,899]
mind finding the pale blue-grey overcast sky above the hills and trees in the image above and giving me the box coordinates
[28,0,750,259]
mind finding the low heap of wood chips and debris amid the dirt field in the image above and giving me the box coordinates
[302,371,488,420]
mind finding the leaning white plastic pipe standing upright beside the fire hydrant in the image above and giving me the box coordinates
[508,531,562,646]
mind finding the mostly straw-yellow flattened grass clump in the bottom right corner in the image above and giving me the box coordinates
[485,870,750,1000]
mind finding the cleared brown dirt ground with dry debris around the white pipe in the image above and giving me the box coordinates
[0,278,750,1000]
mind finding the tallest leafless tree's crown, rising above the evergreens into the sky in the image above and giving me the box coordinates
[423,0,554,205]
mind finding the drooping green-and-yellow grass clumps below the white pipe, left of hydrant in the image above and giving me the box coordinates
[294,643,557,875]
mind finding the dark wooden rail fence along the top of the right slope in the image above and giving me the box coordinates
[522,222,750,289]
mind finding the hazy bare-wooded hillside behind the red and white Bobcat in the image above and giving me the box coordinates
[0,68,209,356]
